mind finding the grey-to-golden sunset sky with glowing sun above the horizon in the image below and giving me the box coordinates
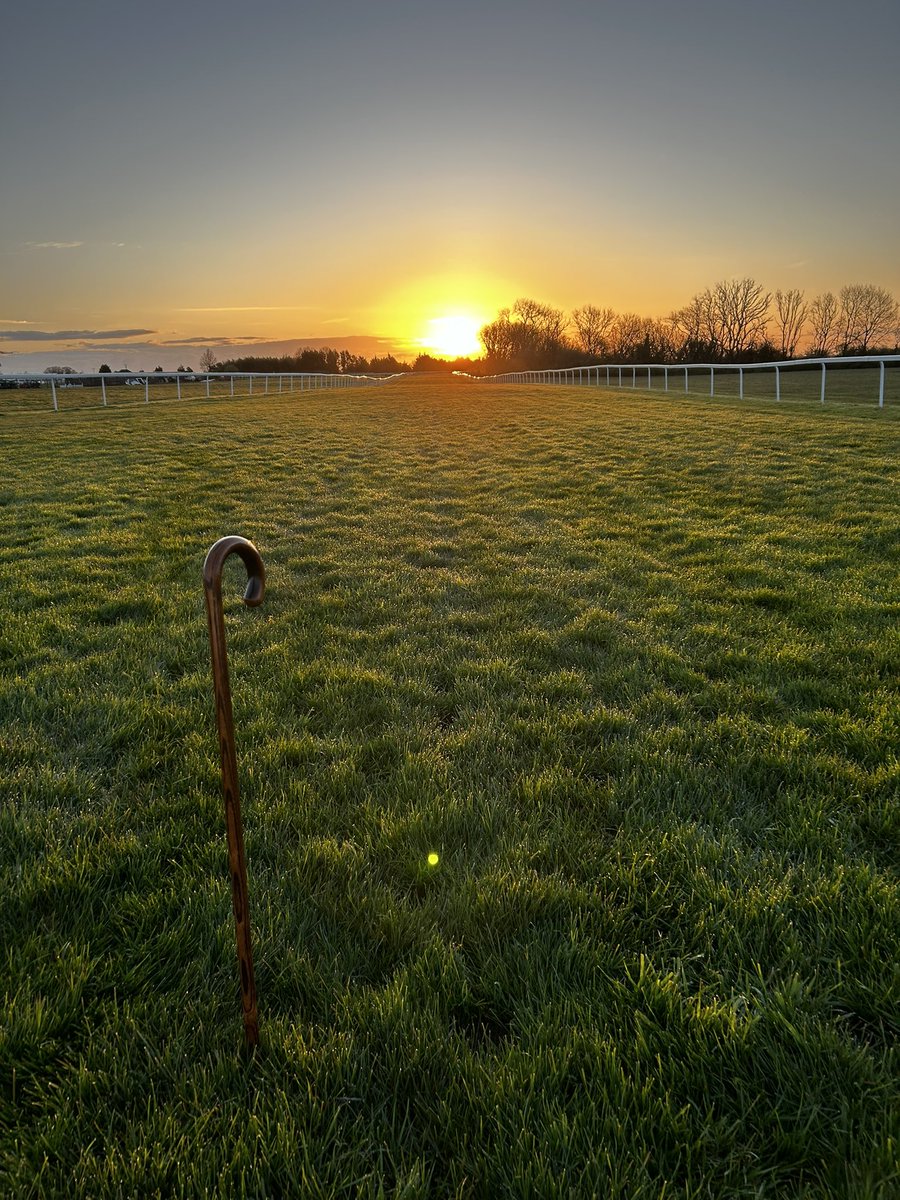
[0,0,900,372]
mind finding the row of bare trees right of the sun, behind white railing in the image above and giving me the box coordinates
[479,278,900,372]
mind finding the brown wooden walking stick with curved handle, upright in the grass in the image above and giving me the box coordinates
[203,536,265,1046]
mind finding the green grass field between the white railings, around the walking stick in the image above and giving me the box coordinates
[0,380,900,1200]
